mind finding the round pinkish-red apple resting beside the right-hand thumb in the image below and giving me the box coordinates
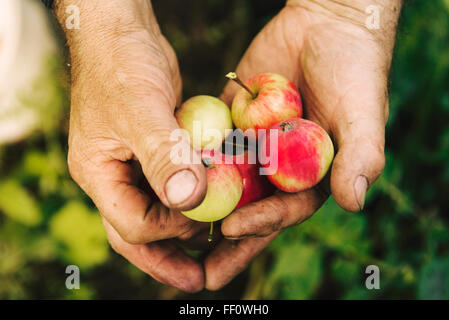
[260,118,334,192]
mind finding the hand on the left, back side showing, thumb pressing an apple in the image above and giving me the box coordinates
[56,0,206,292]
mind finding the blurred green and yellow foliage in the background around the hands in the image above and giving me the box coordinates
[0,0,449,299]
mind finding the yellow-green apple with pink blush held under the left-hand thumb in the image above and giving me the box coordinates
[182,154,243,222]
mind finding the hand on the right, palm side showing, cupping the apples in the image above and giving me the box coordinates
[205,0,401,290]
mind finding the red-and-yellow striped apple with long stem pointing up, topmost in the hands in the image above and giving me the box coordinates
[226,72,302,137]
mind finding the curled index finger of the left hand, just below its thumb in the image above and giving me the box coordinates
[69,150,192,244]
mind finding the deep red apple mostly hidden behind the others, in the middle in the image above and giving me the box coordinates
[205,150,276,209]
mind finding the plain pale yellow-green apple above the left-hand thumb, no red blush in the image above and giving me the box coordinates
[175,95,233,150]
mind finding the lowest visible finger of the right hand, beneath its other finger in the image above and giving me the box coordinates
[204,233,278,290]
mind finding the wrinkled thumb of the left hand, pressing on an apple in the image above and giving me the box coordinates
[121,98,207,210]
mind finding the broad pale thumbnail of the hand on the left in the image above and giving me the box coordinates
[165,170,198,205]
